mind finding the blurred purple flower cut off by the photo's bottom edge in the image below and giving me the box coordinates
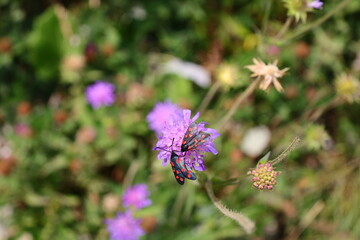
[105,211,145,240]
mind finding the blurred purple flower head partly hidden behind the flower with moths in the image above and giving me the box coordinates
[146,101,181,135]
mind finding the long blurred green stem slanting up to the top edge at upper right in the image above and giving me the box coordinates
[283,0,351,42]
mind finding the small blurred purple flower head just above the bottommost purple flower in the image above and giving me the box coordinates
[122,184,151,209]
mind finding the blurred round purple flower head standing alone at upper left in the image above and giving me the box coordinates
[86,81,115,108]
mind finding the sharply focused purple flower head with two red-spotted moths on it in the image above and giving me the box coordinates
[154,109,220,171]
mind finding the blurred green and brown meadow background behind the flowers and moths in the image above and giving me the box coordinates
[0,0,360,240]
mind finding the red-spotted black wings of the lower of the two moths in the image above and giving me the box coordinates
[170,152,196,185]
